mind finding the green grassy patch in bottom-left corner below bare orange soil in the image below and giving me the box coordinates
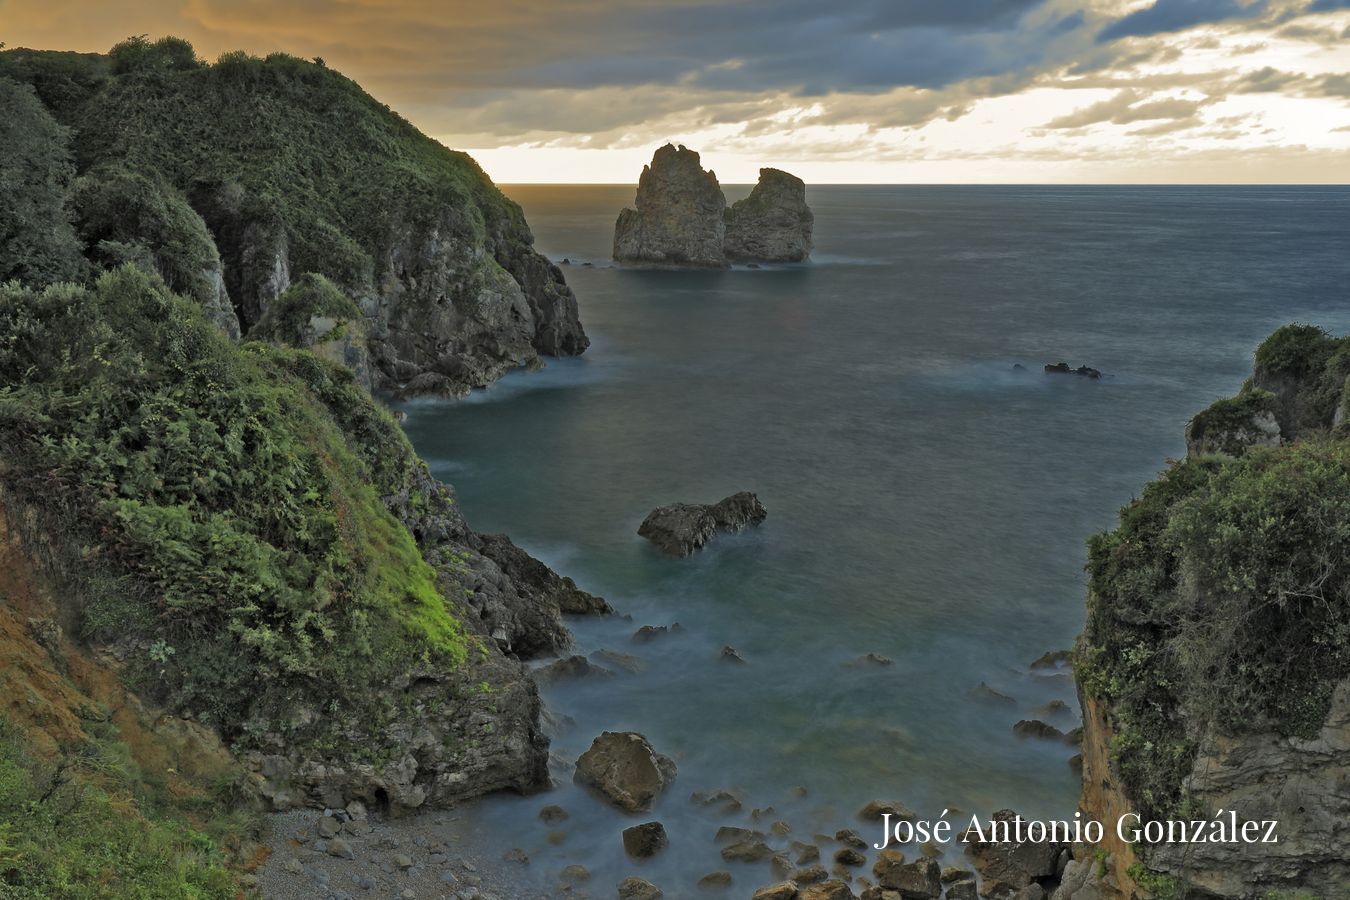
[0,718,251,900]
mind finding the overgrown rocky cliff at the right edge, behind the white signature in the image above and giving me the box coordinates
[1060,325,1350,900]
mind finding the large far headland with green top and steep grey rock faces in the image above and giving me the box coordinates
[0,38,589,395]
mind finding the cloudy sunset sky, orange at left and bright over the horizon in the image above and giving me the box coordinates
[0,0,1350,184]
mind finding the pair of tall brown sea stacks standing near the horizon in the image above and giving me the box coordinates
[614,144,815,269]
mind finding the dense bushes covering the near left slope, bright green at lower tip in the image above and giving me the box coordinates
[0,266,470,742]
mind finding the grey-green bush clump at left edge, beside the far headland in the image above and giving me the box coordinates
[0,77,85,285]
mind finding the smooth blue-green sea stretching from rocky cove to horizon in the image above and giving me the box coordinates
[396,186,1350,896]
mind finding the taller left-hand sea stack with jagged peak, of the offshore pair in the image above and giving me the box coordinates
[614,144,726,269]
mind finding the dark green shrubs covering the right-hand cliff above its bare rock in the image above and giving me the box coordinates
[1076,329,1350,818]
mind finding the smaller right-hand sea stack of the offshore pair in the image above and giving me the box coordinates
[724,169,815,263]
